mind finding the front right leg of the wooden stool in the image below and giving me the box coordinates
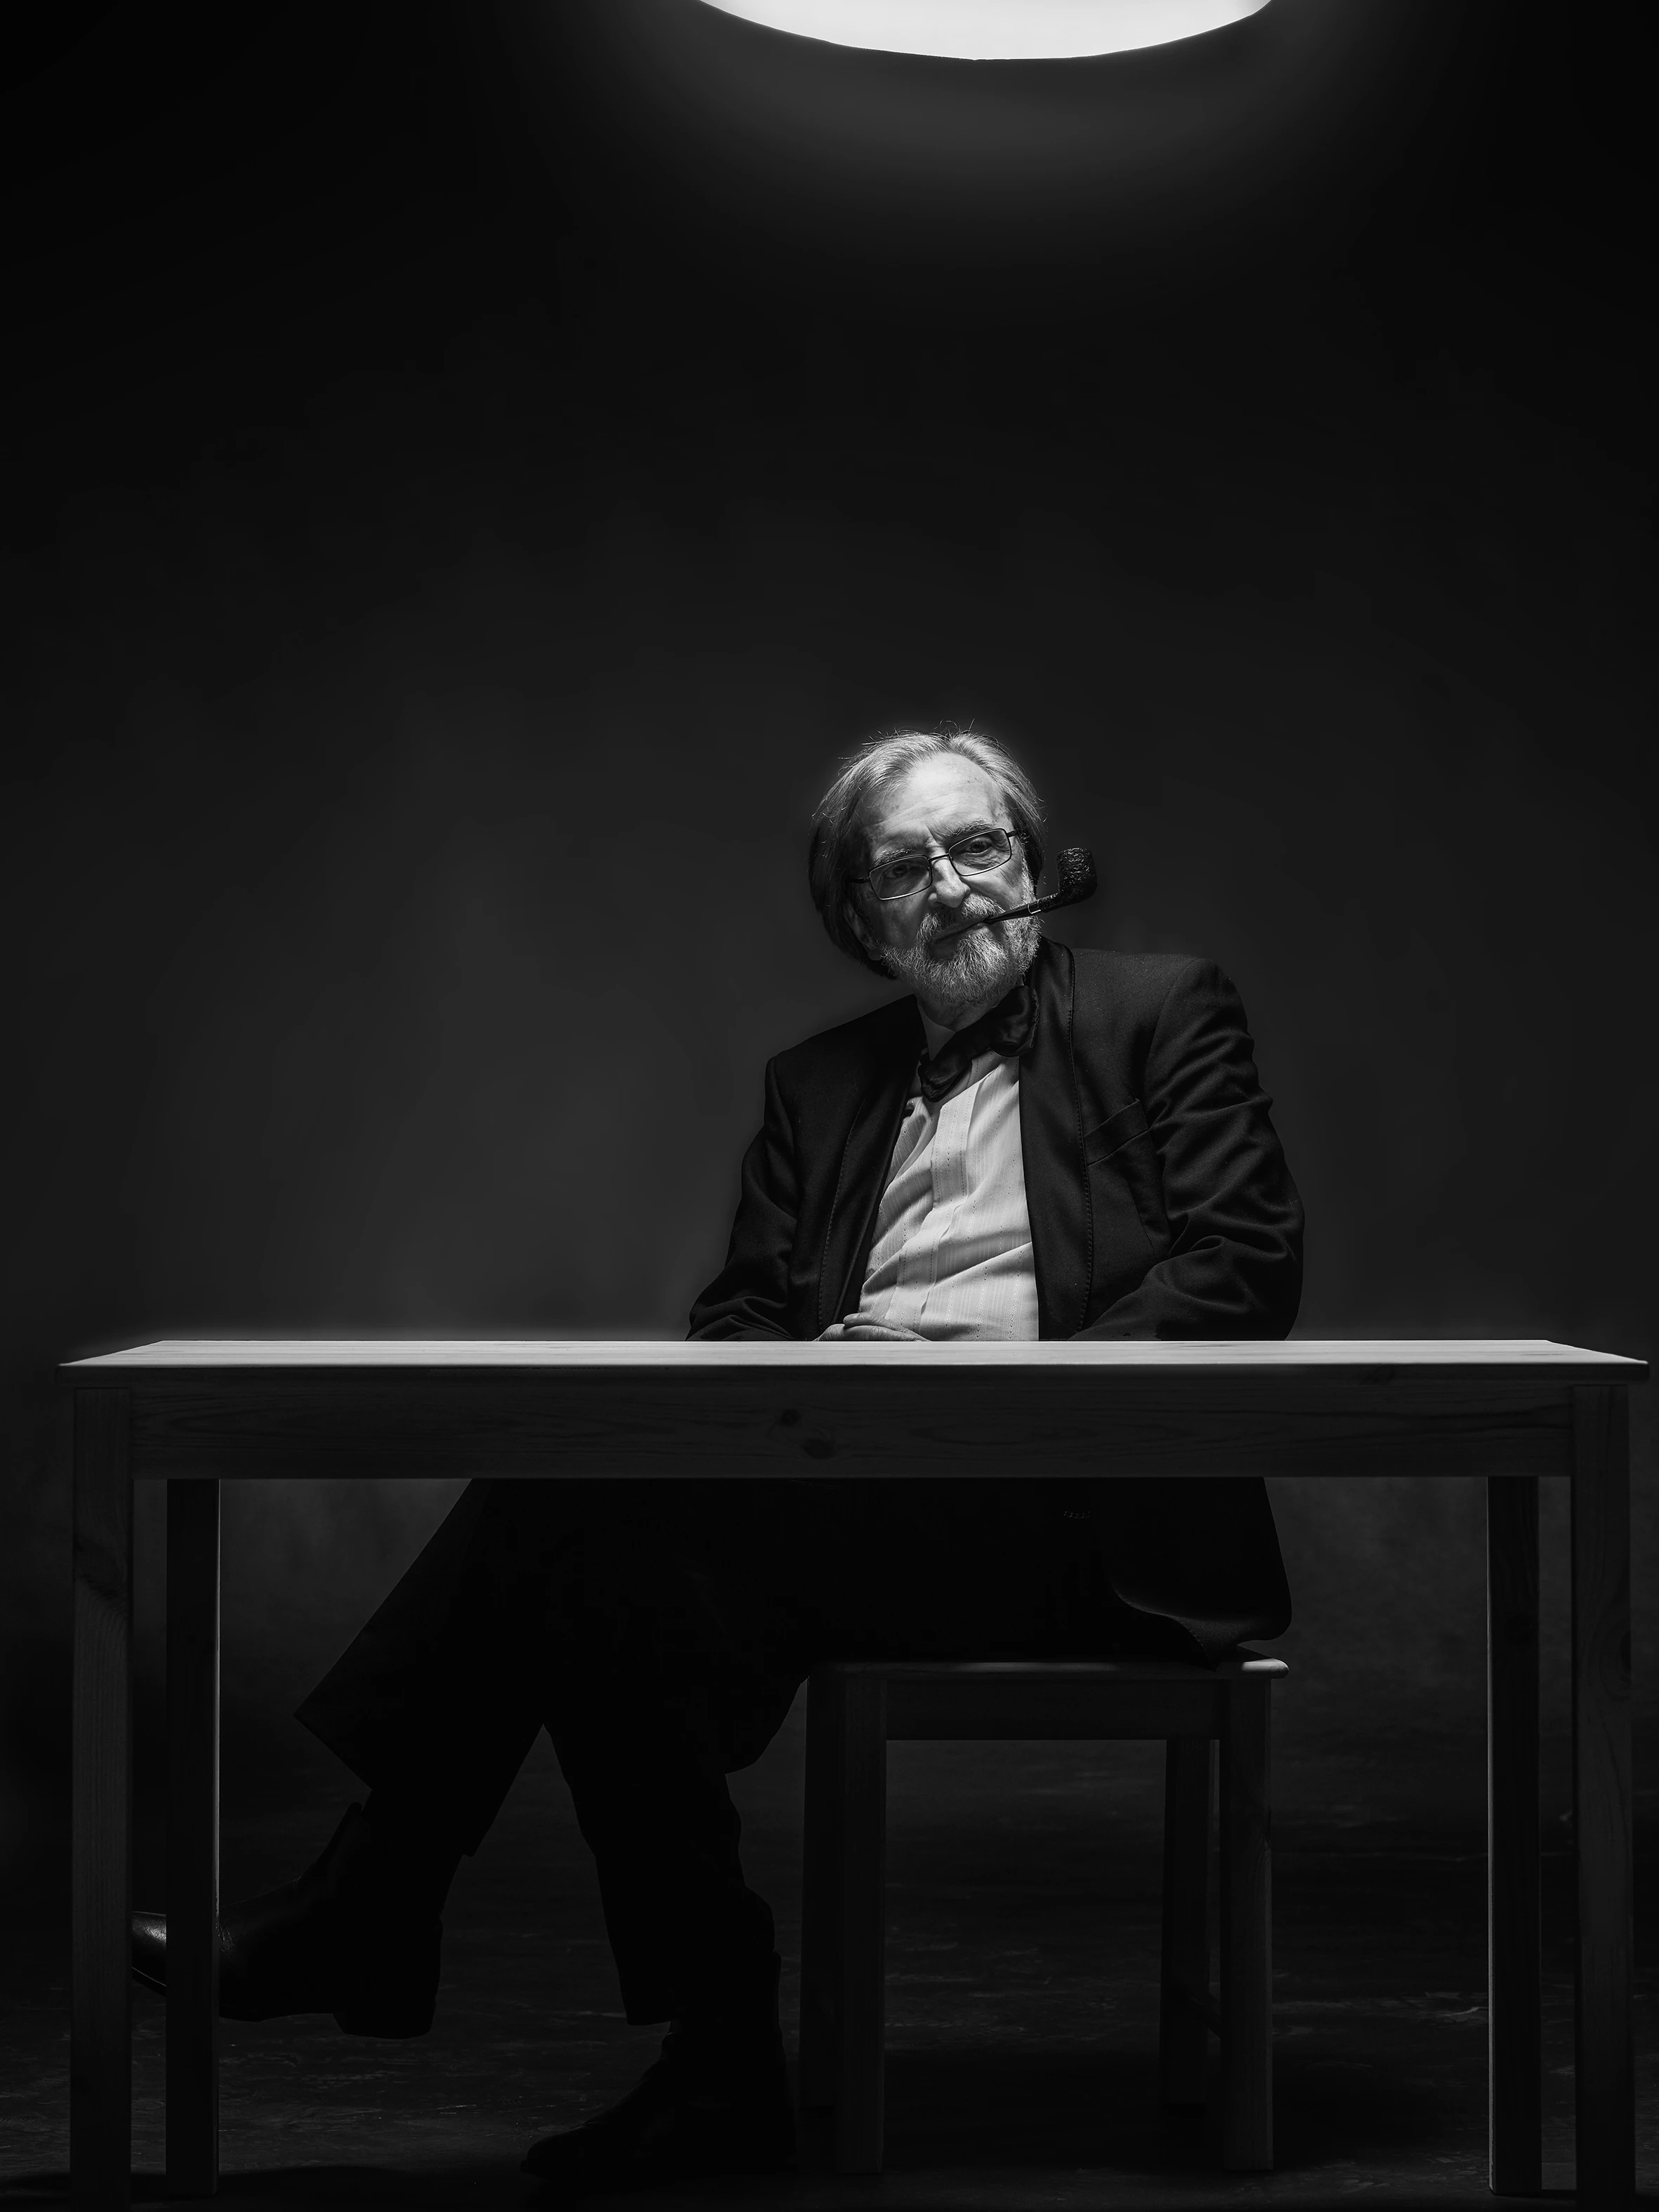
[1221,1675,1274,2172]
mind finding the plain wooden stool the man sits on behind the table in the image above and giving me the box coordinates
[801,1650,1287,2174]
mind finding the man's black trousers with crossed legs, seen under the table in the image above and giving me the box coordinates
[299,1478,1199,2022]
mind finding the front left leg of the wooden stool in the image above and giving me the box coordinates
[834,1673,887,2174]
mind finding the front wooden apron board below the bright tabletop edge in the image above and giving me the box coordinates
[110,1365,1573,1480]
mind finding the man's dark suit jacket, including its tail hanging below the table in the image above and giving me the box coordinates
[690,942,1303,1652]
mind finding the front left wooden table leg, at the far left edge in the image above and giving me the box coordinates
[69,1389,133,2212]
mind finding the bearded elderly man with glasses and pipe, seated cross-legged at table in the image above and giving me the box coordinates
[135,732,1303,2190]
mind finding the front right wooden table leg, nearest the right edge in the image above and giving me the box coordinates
[1573,1389,1634,2212]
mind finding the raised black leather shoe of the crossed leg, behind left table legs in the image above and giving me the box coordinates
[133,1805,442,2035]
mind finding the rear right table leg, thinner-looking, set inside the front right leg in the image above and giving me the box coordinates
[1486,1475,1544,2197]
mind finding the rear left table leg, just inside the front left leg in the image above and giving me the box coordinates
[166,1482,219,2197]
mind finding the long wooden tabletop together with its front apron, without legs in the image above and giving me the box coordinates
[60,1338,1648,1480]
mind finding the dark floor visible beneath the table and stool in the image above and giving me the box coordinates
[0,1710,1659,2212]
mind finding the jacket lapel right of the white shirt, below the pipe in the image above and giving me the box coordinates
[1020,940,1095,1338]
